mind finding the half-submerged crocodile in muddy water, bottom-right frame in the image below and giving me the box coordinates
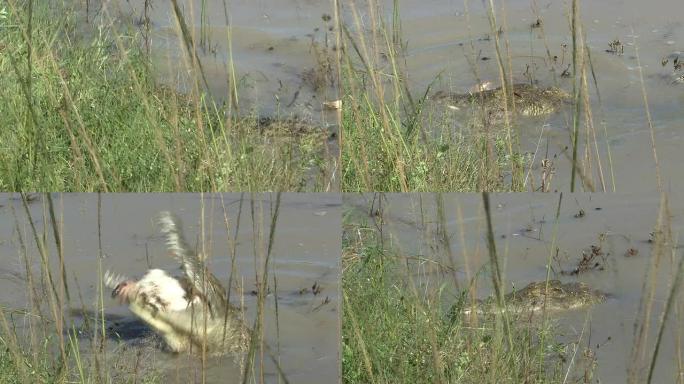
[463,280,608,315]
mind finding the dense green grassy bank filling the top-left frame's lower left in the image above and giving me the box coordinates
[0,0,334,192]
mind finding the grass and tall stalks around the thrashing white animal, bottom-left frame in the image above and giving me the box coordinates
[0,193,289,383]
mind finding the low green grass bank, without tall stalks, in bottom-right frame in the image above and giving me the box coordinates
[342,218,572,383]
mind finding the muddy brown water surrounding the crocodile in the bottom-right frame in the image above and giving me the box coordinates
[345,194,684,383]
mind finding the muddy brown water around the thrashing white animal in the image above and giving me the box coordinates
[0,194,341,383]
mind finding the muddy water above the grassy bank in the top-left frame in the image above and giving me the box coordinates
[107,0,337,122]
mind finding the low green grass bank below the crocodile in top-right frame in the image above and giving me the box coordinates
[342,93,526,192]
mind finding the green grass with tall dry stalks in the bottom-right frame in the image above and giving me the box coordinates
[342,194,684,383]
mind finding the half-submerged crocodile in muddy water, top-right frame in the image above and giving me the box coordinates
[432,83,571,125]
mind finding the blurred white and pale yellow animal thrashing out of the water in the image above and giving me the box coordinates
[105,212,250,354]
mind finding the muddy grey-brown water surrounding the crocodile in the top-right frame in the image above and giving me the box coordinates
[358,0,684,192]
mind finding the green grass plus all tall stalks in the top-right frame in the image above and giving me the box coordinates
[340,1,615,192]
